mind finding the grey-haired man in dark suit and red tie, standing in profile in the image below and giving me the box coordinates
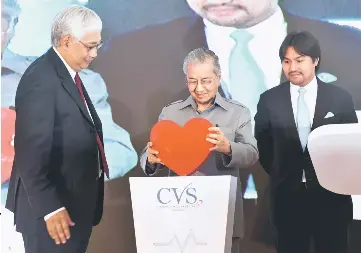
[6,6,108,253]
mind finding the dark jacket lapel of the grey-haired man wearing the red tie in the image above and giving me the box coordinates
[47,48,94,125]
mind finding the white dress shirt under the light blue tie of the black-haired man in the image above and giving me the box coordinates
[290,76,318,182]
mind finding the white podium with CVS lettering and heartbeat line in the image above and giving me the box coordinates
[129,176,237,253]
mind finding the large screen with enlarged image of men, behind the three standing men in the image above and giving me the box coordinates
[1,0,361,253]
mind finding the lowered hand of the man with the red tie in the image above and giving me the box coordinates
[45,210,75,244]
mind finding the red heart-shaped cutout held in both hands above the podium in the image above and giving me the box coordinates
[150,118,214,176]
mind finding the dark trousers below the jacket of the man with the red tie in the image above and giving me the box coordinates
[23,220,92,253]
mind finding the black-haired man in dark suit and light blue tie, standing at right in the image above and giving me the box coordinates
[255,32,358,253]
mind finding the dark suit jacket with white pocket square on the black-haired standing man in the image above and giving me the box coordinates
[255,80,357,224]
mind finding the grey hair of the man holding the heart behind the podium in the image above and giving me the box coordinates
[183,47,221,76]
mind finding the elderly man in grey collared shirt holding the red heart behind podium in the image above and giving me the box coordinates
[140,48,258,253]
